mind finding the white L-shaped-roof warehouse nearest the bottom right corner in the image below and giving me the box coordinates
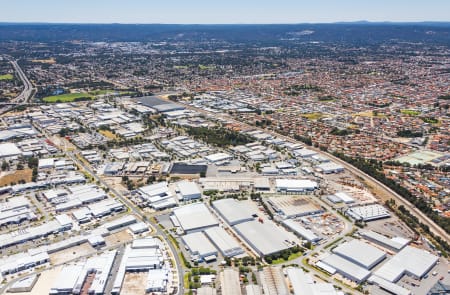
[374,246,439,283]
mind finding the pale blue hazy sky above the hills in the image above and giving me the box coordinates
[0,0,450,24]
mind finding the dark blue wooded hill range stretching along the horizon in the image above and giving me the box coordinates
[0,21,450,45]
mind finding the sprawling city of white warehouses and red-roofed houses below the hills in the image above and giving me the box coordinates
[0,21,450,295]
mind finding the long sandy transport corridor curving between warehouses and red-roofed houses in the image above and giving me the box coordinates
[161,97,450,242]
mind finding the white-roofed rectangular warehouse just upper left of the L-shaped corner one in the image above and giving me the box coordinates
[333,239,386,269]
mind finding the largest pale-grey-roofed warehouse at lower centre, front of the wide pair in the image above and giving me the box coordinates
[233,220,297,257]
